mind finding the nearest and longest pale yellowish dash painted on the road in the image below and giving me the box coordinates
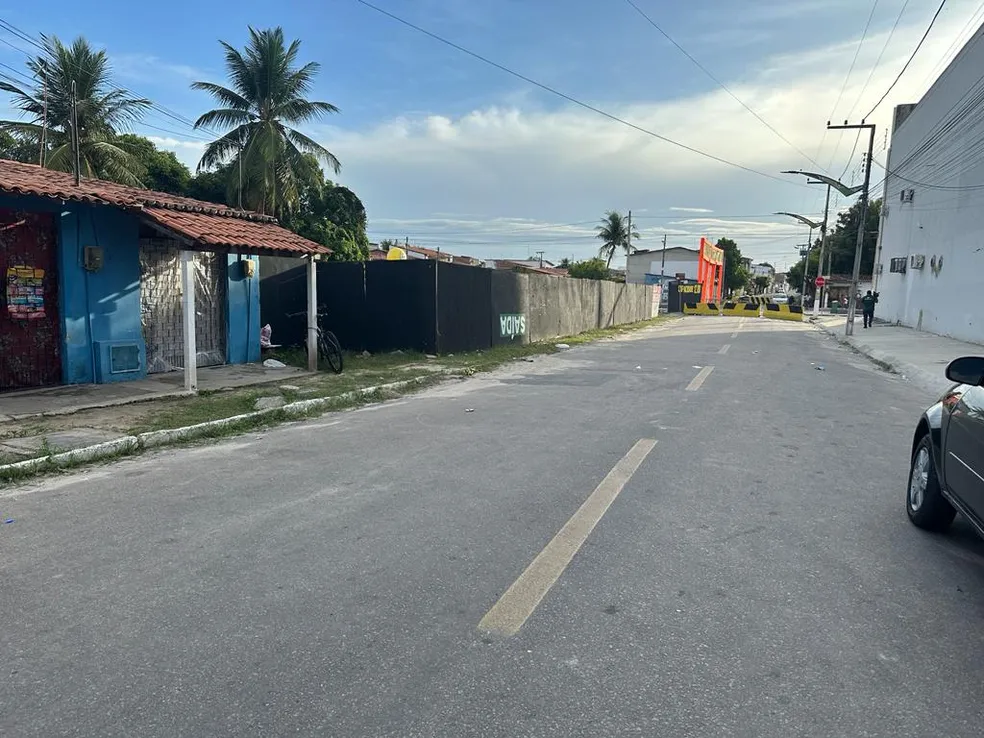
[478,438,656,636]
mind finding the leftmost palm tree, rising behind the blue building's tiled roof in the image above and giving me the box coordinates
[0,36,151,186]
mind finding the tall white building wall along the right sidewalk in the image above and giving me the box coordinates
[875,28,984,343]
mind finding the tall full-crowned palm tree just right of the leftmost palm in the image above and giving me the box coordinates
[192,27,341,215]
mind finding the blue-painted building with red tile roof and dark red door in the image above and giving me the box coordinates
[0,160,327,391]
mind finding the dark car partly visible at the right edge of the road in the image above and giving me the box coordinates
[906,356,984,535]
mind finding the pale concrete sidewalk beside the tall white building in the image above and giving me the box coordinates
[814,315,984,394]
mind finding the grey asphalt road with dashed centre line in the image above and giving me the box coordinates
[0,318,984,738]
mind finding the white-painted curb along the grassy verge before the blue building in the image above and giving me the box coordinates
[0,370,438,484]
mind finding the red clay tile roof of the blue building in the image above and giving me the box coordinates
[0,159,331,254]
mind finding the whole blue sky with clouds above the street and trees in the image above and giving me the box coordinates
[0,0,984,266]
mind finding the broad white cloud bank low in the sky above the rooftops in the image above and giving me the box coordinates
[140,0,977,268]
